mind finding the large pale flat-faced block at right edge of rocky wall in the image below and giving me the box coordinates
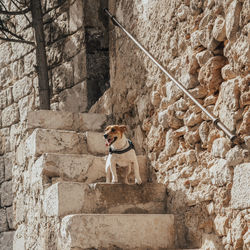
[231,163,250,209]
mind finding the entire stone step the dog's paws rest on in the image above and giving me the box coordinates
[44,182,166,217]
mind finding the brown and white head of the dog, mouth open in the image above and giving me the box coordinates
[103,125,127,146]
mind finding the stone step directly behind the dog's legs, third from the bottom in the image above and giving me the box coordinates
[37,153,148,183]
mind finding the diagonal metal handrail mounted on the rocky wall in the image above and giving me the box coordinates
[104,8,236,141]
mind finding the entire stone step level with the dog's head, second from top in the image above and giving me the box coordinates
[25,128,108,156]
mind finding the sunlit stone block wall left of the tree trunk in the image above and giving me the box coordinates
[0,1,39,249]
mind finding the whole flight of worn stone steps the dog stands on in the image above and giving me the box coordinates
[23,111,175,250]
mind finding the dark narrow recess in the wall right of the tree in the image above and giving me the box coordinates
[85,0,110,109]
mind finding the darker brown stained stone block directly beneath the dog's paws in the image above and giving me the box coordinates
[85,183,166,214]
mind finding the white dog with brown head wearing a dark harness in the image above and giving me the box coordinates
[104,125,142,184]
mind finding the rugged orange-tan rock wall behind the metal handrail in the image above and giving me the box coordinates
[91,0,250,249]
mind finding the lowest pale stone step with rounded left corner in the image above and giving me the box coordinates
[59,214,175,250]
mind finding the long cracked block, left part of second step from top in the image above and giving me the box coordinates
[26,128,87,156]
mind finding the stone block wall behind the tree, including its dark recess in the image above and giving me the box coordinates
[0,0,109,249]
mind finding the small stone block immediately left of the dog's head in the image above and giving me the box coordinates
[86,131,108,155]
